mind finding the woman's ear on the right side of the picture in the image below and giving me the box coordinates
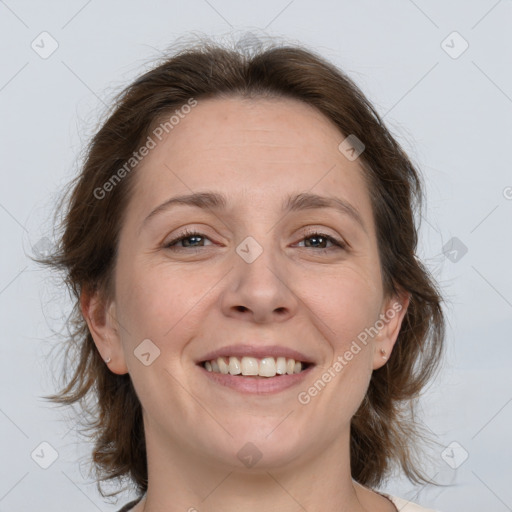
[373,291,411,370]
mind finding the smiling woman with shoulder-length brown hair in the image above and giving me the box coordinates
[39,38,444,512]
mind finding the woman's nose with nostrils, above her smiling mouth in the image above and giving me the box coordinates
[222,240,299,323]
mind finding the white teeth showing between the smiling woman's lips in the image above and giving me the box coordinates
[200,356,313,378]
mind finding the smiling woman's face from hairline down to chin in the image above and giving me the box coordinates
[89,98,407,467]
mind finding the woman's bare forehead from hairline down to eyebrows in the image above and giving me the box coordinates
[127,98,371,230]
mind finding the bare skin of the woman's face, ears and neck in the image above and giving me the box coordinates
[81,98,409,512]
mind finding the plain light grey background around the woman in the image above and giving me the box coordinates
[0,0,512,512]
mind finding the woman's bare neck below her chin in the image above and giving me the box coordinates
[139,420,372,512]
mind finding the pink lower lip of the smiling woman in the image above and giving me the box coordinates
[198,365,313,395]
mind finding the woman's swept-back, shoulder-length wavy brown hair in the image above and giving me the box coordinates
[37,37,445,496]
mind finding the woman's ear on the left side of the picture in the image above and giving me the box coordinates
[80,290,128,375]
